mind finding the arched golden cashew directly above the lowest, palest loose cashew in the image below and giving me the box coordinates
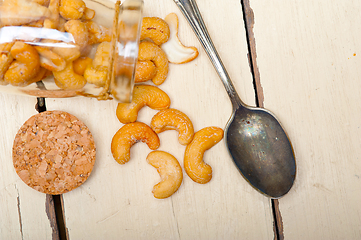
[150,108,194,145]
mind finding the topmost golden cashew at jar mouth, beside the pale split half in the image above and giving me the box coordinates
[140,17,170,45]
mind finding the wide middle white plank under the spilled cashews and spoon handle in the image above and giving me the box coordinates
[46,0,273,239]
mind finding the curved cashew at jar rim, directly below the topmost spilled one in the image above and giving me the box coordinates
[138,41,169,85]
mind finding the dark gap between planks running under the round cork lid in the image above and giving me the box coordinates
[35,98,68,240]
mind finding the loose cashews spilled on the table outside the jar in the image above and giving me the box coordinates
[111,13,223,199]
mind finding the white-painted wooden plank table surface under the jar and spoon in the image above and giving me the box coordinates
[0,0,361,240]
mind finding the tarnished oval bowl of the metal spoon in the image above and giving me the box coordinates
[225,106,296,198]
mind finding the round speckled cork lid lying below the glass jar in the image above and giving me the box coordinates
[13,111,96,195]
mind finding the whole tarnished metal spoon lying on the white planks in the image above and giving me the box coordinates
[174,0,296,198]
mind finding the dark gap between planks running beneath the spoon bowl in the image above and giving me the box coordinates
[240,0,284,240]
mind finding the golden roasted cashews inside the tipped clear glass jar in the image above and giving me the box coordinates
[0,0,101,90]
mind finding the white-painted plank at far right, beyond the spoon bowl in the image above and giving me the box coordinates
[250,0,361,239]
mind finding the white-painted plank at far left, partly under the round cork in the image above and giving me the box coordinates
[0,93,52,240]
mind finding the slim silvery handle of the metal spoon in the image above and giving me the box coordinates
[174,0,244,108]
